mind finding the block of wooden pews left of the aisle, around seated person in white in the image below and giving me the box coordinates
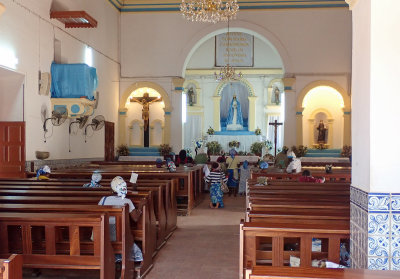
[0,176,177,278]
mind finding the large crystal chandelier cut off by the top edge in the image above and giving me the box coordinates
[180,0,239,23]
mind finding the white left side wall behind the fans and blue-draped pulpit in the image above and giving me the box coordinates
[0,0,120,160]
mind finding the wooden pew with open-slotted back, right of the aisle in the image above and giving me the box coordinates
[239,220,350,278]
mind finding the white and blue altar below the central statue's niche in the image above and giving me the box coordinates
[206,131,265,152]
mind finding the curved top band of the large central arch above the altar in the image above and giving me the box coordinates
[177,20,292,77]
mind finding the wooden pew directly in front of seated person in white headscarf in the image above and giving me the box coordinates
[0,195,156,275]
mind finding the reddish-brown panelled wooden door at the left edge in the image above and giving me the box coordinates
[0,122,25,177]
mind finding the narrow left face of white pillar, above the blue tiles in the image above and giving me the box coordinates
[351,0,372,192]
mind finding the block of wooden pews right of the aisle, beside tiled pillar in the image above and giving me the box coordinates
[239,179,400,279]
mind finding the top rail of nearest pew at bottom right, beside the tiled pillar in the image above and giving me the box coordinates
[245,263,400,279]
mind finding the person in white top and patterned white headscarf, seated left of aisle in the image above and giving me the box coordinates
[98,176,145,262]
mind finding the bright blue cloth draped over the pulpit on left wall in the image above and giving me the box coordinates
[50,63,98,100]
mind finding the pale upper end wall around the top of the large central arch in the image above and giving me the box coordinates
[121,8,351,77]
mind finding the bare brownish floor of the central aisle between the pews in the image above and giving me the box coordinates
[146,196,245,279]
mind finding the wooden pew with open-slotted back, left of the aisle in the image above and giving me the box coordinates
[0,213,115,279]
